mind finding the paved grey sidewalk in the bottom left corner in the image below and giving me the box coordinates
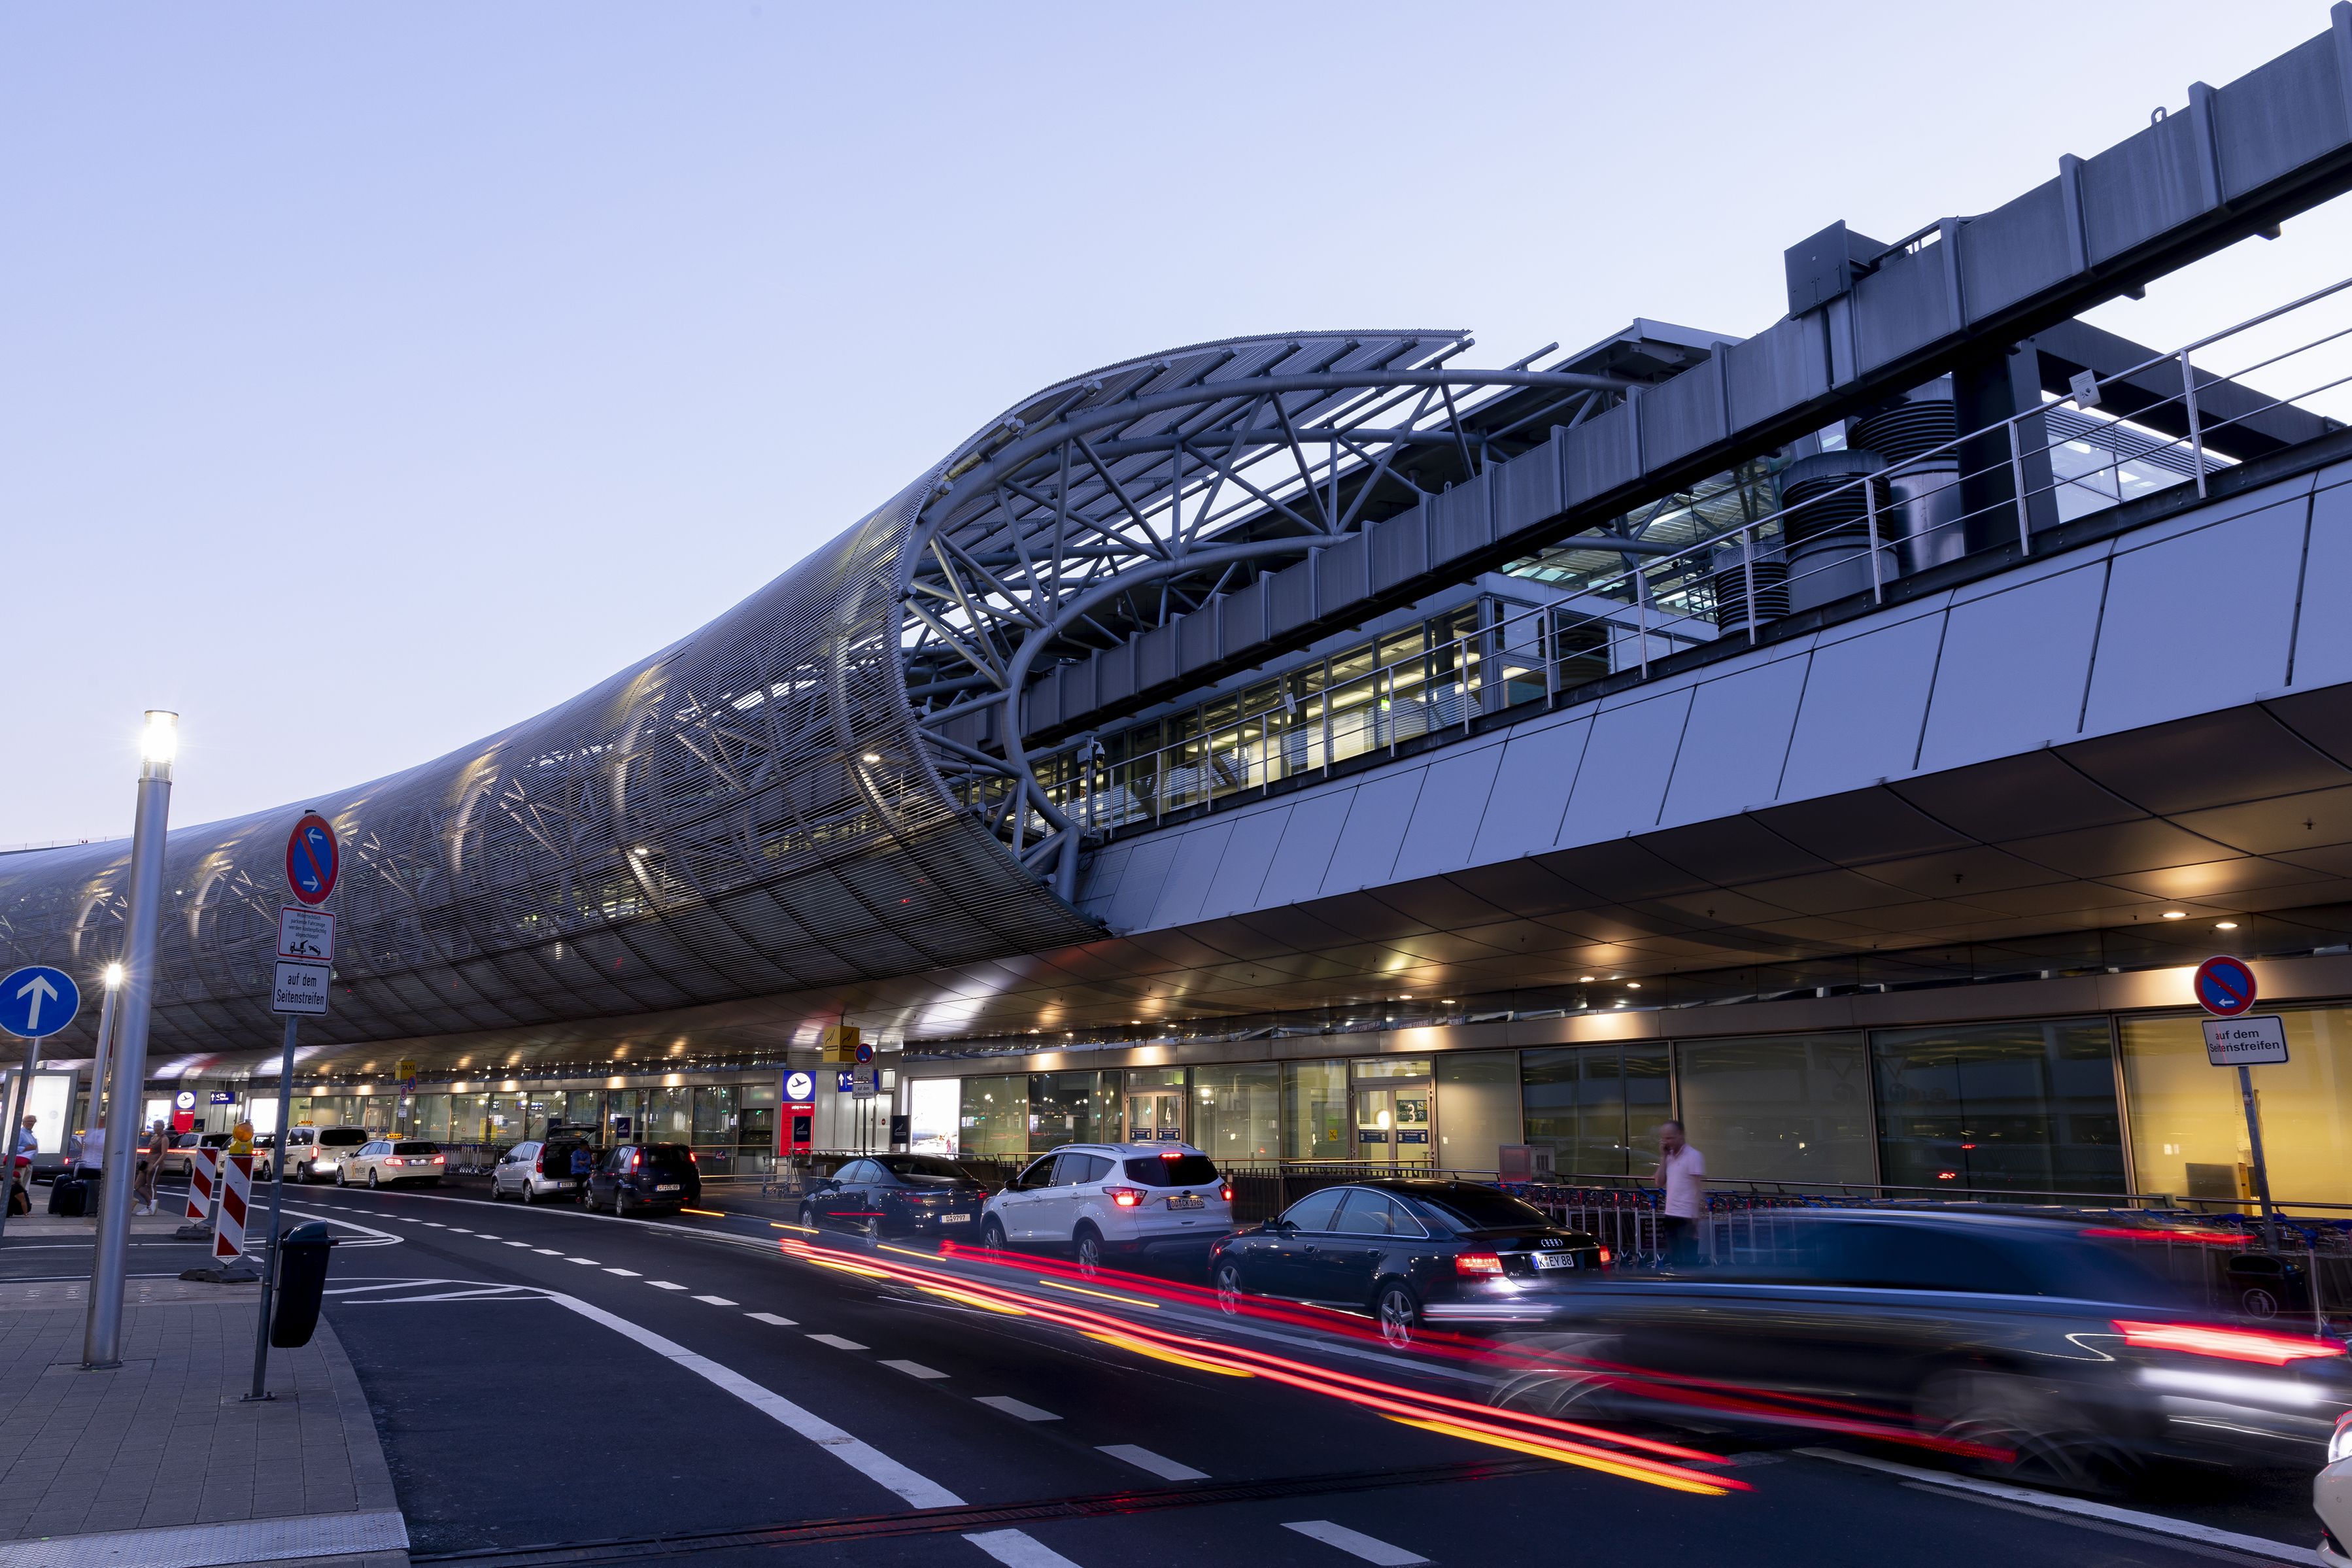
[0,1278,409,1568]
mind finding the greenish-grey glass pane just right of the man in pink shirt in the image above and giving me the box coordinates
[1675,1034,1875,1182]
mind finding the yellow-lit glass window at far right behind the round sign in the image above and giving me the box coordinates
[2117,1006,2352,1204]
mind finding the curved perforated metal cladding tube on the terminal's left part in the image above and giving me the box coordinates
[0,479,1100,1053]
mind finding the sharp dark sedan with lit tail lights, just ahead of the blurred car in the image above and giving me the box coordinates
[1209,1180,1609,1344]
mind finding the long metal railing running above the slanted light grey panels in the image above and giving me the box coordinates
[1035,277,2352,832]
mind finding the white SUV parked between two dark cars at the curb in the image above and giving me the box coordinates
[981,1142,1233,1269]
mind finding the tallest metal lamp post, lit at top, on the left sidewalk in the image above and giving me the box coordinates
[82,710,179,1368]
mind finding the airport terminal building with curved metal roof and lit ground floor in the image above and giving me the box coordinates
[14,5,2352,1204]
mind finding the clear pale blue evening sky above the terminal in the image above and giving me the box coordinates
[0,0,2352,844]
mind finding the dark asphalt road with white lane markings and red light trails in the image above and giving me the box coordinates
[0,1187,2317,1568]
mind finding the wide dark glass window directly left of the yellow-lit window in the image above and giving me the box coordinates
[1870,1018,2124,1192]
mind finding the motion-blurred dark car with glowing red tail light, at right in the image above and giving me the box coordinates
[1496,1208,2352,1490]
